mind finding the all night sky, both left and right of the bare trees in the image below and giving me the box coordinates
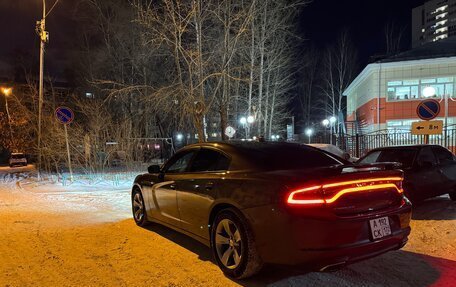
[0,0,424,77]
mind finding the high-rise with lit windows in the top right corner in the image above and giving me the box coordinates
[412,0,456,48]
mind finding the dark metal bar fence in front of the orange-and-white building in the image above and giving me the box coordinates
[330,125,456,157]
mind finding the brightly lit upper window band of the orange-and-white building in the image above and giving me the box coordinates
[387,77,453,101]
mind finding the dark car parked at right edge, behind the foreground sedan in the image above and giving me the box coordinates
[357,145,456,202]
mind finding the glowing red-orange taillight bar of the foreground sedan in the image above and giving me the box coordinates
[287,177,403,205]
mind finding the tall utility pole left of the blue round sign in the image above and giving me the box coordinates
[36,0,49,179]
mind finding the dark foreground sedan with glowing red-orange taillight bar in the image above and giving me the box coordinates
[132,142,411,279]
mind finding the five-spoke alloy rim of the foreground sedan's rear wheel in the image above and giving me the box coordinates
[215,219,243,269]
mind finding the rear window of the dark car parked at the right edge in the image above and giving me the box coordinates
[359,148,417,168]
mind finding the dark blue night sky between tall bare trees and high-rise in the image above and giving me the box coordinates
[300,0,424,68]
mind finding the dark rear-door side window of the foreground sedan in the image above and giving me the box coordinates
[190,148,230,172]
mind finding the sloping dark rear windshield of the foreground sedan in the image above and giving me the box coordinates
[242,144,344,170]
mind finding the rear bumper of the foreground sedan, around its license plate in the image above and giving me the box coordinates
[243,203,411,270]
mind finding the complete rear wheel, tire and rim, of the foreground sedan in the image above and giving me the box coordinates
[211,208,263,279]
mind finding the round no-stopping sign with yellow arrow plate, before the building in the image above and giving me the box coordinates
[412,99,443,144]
